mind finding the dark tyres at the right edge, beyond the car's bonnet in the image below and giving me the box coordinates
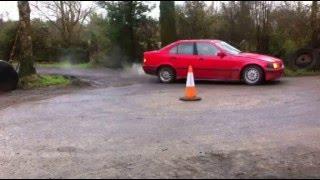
[288,48,320,70]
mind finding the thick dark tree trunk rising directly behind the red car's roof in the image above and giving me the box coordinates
[160,1,177,46]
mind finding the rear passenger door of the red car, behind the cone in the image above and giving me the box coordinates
[169,42,196,78]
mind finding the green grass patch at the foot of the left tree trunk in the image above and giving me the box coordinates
[19,75,71,89]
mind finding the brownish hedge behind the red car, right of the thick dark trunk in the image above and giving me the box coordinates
[176,1,320,59]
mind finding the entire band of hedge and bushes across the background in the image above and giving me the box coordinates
[0,1,320,68]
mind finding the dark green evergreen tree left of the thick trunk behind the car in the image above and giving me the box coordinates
[98,1,151,62]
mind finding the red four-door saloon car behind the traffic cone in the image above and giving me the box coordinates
[143,40,284,85]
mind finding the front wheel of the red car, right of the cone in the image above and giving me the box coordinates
[242,65,265,85]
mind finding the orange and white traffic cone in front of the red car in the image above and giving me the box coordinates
[180,66,201,101]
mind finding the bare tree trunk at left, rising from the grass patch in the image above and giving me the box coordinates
[18,1,36,77]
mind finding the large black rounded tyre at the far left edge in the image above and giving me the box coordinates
[0,60,19,93]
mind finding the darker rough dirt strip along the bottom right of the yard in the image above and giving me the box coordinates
[77,146,320,179]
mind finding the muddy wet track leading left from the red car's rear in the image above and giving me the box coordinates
[0,67,148,110]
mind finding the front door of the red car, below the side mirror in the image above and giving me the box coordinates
[193,42,233,80]
